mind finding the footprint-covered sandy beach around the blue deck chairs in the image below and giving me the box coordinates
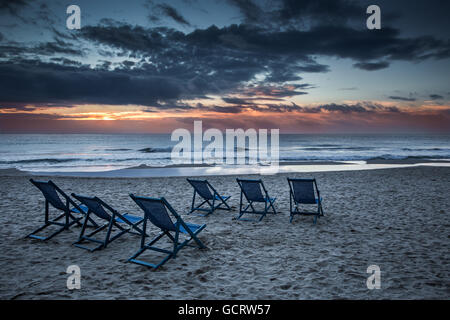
[0,167,450,299]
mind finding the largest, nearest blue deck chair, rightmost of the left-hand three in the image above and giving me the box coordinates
[128,194,206,269]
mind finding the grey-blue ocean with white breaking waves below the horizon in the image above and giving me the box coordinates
[0,134,450,172]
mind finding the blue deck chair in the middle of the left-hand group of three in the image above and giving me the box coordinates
[72,193,144,252]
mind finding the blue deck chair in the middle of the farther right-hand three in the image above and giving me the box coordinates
[236,179,277,221]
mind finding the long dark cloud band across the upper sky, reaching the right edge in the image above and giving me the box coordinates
[82,25,450,63]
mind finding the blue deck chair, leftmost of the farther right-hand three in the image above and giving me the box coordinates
[186,179,231,217]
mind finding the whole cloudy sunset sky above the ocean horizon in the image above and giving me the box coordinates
[0,0,450,133]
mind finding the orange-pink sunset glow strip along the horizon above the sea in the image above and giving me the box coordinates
[0,99,450,133]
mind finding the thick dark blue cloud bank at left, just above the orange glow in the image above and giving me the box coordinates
[0,62,183,105]
